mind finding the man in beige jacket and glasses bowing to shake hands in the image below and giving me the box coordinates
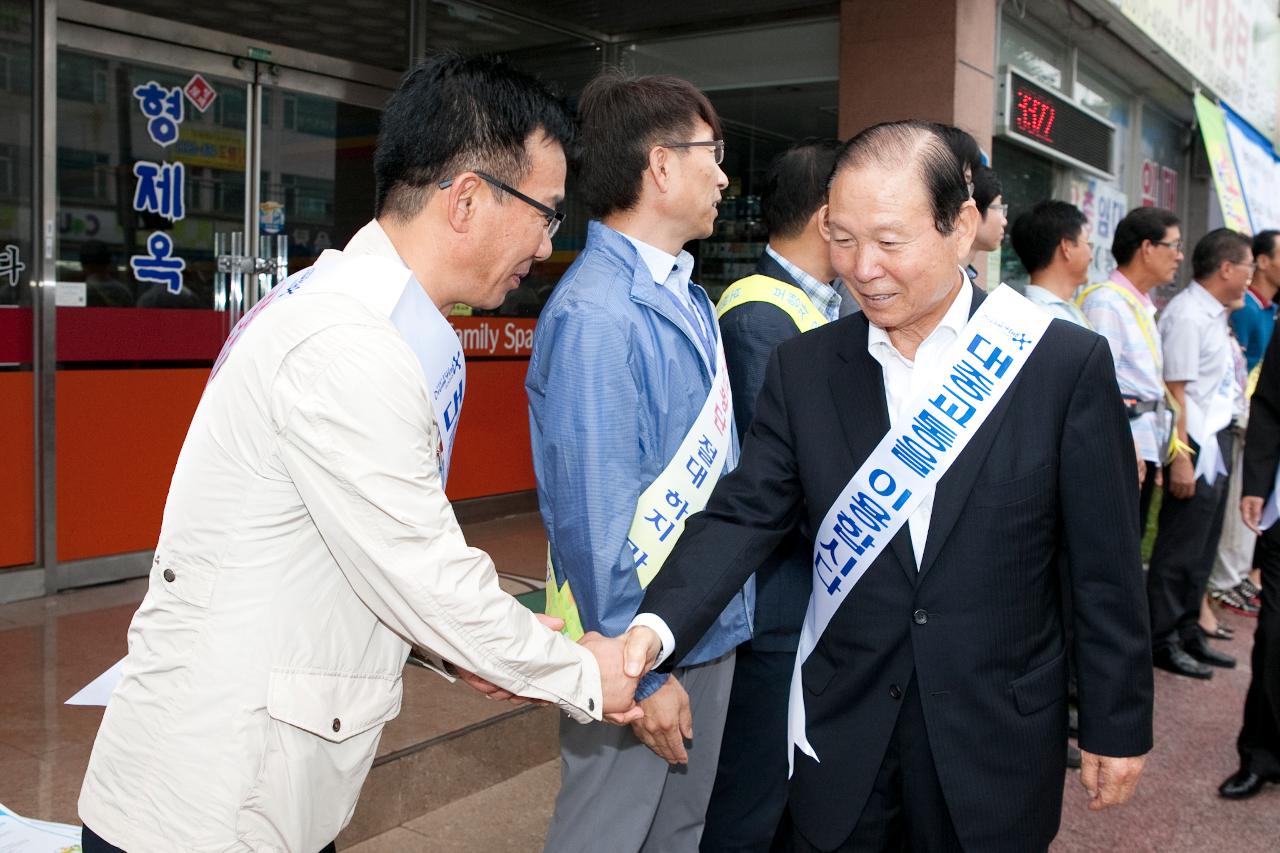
[79,56,637,853]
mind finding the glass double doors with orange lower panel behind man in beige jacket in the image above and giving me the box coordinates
[45,22,385,573]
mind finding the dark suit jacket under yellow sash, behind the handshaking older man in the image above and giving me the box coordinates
[719,249,813,652]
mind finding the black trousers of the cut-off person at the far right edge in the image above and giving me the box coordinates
[1235,525,1280,776]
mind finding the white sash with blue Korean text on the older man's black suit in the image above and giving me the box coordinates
[787,284,1052,770]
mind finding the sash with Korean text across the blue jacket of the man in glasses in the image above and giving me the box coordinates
[627,341,733,588]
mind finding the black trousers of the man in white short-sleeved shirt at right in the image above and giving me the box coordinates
[1147,429,1235,652]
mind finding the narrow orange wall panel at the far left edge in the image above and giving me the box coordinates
[0,371,36,566]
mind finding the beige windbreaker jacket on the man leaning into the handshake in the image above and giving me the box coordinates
[79,223,602,853]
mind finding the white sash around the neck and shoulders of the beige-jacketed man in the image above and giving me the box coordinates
[210,248,467,483]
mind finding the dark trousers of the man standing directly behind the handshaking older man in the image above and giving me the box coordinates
[699,643,796,853]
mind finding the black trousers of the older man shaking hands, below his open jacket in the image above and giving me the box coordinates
[774,676,963,853]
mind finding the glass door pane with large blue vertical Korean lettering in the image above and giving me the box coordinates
[56,49,244,309]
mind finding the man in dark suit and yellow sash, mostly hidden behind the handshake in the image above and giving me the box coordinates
[701,140,844,853]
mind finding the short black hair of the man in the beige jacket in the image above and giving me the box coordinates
[374,53,573,220]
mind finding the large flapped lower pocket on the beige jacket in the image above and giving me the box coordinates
[236,667,401,850]
